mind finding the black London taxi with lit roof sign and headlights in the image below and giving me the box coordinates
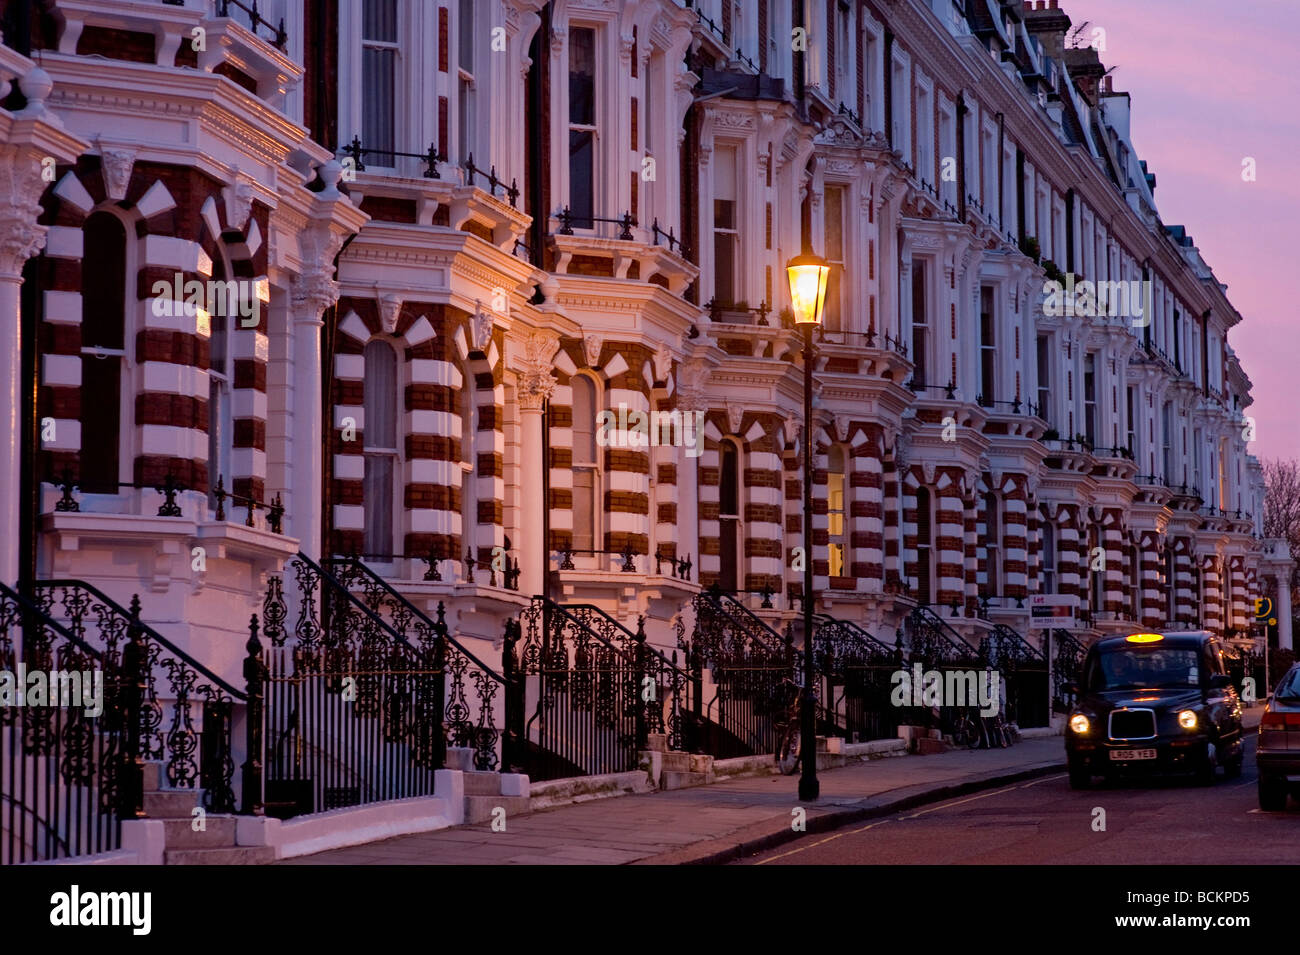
[1065,631,1245,789]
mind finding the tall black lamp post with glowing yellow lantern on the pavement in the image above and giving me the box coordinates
[785,253,831,803]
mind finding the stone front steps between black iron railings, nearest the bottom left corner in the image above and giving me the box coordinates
[144,761,276,865]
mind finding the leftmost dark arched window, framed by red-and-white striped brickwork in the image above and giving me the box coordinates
[81,212,130,494]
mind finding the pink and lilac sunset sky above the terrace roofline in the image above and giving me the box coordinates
[1061,0,1300,459]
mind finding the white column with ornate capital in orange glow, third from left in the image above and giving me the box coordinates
[517,334,559,596]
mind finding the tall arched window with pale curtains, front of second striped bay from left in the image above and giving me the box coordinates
[361,339,398,561]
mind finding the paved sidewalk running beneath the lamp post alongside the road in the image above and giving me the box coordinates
[285,737,1065,865]
